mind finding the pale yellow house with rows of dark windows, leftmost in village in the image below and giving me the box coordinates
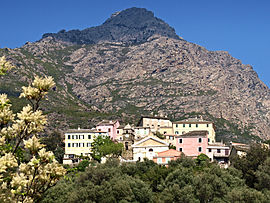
[63,128,108,164]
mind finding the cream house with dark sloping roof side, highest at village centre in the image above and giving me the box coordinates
[137,116,172,132]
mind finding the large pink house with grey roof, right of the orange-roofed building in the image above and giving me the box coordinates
[176,131,208,157]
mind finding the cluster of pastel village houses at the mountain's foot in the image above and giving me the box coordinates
[63,116,249,168]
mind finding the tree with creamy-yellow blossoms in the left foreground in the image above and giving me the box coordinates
[0,57,66,202]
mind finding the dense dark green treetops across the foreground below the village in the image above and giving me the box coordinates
[43,155,270,203]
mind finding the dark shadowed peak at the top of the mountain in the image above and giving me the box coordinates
[42,8,180,44]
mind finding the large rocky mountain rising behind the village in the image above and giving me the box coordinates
[0,8,270,142]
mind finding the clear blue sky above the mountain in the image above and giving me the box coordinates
[0,0,270,87]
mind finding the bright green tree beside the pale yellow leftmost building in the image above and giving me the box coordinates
[91,136,124,162]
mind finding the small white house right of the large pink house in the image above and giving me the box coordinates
[206,142,230,168]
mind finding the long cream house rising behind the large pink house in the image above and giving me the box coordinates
[173,118,216,143]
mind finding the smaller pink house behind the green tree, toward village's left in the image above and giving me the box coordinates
[96,120,120,140]
